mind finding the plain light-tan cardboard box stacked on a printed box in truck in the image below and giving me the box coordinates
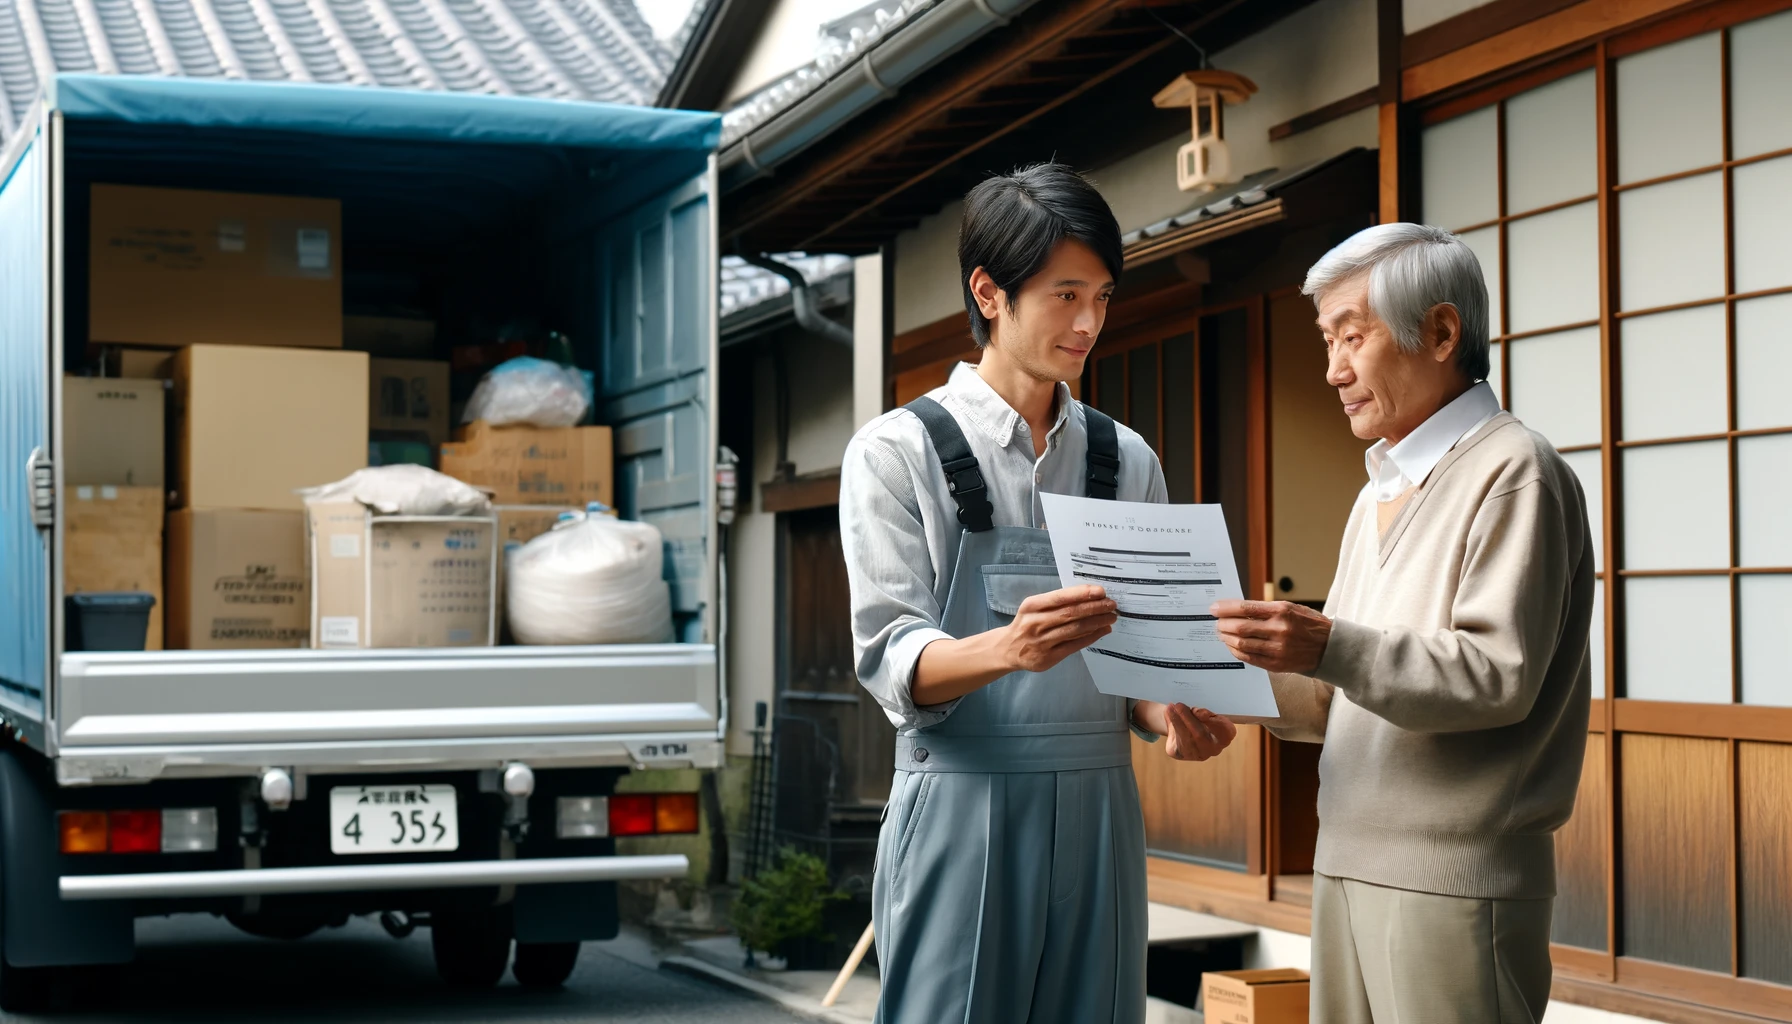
[174,344,367,511]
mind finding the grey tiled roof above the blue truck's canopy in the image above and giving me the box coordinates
[0,0,672,138]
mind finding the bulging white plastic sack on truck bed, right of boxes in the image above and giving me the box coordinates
[504,511,672,644]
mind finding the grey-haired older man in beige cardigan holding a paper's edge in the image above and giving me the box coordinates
[1215,224,1593,1024]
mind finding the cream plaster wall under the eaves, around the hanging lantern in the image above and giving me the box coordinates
[892,0,1376,334]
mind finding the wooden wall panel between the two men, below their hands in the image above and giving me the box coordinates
[1133,725,1262,870]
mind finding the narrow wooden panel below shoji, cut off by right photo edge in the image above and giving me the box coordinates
[1736,742,1792,985]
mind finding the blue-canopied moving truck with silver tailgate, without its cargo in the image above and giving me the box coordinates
[0,75,728,1006]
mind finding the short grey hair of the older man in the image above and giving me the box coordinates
[1301,224,1491,380]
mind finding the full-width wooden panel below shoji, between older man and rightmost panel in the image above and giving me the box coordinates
[1618,735,1731,974]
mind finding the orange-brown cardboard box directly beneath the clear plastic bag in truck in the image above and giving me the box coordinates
[441,421,616,508]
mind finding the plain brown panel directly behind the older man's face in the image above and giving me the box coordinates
[1268,294,1369,601]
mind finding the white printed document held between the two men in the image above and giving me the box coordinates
[1039,493,1278,717]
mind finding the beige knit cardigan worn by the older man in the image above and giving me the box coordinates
[1269,412,1595,898]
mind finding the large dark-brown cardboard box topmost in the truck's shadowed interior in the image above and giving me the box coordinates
[88,185,342,348]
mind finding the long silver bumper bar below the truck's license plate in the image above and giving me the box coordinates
[61,854,690,900]
